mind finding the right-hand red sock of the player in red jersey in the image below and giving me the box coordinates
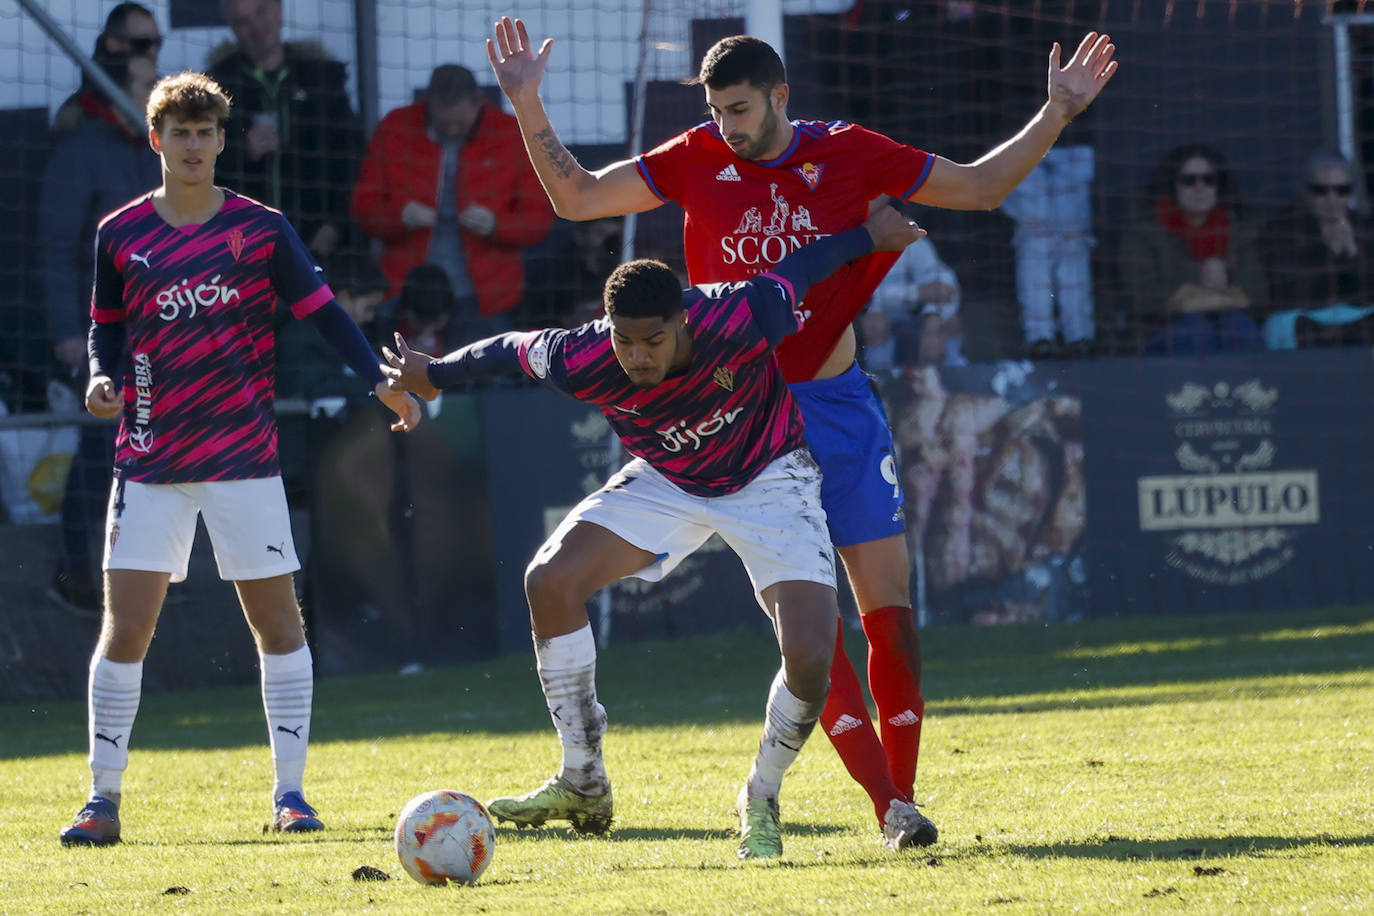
[862,607,926,799]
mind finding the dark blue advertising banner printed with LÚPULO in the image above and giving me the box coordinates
[1081,349,1374,614]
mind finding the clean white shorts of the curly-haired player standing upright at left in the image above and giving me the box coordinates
[103,477,301,582]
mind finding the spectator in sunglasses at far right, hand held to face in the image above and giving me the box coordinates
[1260,152,1374,350]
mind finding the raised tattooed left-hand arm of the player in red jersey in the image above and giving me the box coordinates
[486,16,662,220]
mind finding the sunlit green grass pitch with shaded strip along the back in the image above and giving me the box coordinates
[0,607,1374,916]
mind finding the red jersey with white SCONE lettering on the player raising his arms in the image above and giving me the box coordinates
[636,121,934,382]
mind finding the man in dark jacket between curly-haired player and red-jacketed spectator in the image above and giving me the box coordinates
[207,0,363,258]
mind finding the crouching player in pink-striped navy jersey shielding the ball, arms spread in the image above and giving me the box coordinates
[383,207,925,858]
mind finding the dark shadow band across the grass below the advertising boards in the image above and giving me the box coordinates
[0,607,1374,759]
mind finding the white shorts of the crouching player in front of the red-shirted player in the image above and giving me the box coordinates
[550,449,835,593]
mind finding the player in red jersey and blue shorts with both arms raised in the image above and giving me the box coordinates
[486,18,1117,850]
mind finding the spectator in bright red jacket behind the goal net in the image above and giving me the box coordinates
[352,63,554,347]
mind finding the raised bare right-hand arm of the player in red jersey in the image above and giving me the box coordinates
[911,32,1117,210]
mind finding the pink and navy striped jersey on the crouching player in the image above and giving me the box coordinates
[518,273,802,496]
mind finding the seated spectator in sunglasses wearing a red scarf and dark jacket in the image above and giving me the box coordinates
[1121,143,1265,356]
